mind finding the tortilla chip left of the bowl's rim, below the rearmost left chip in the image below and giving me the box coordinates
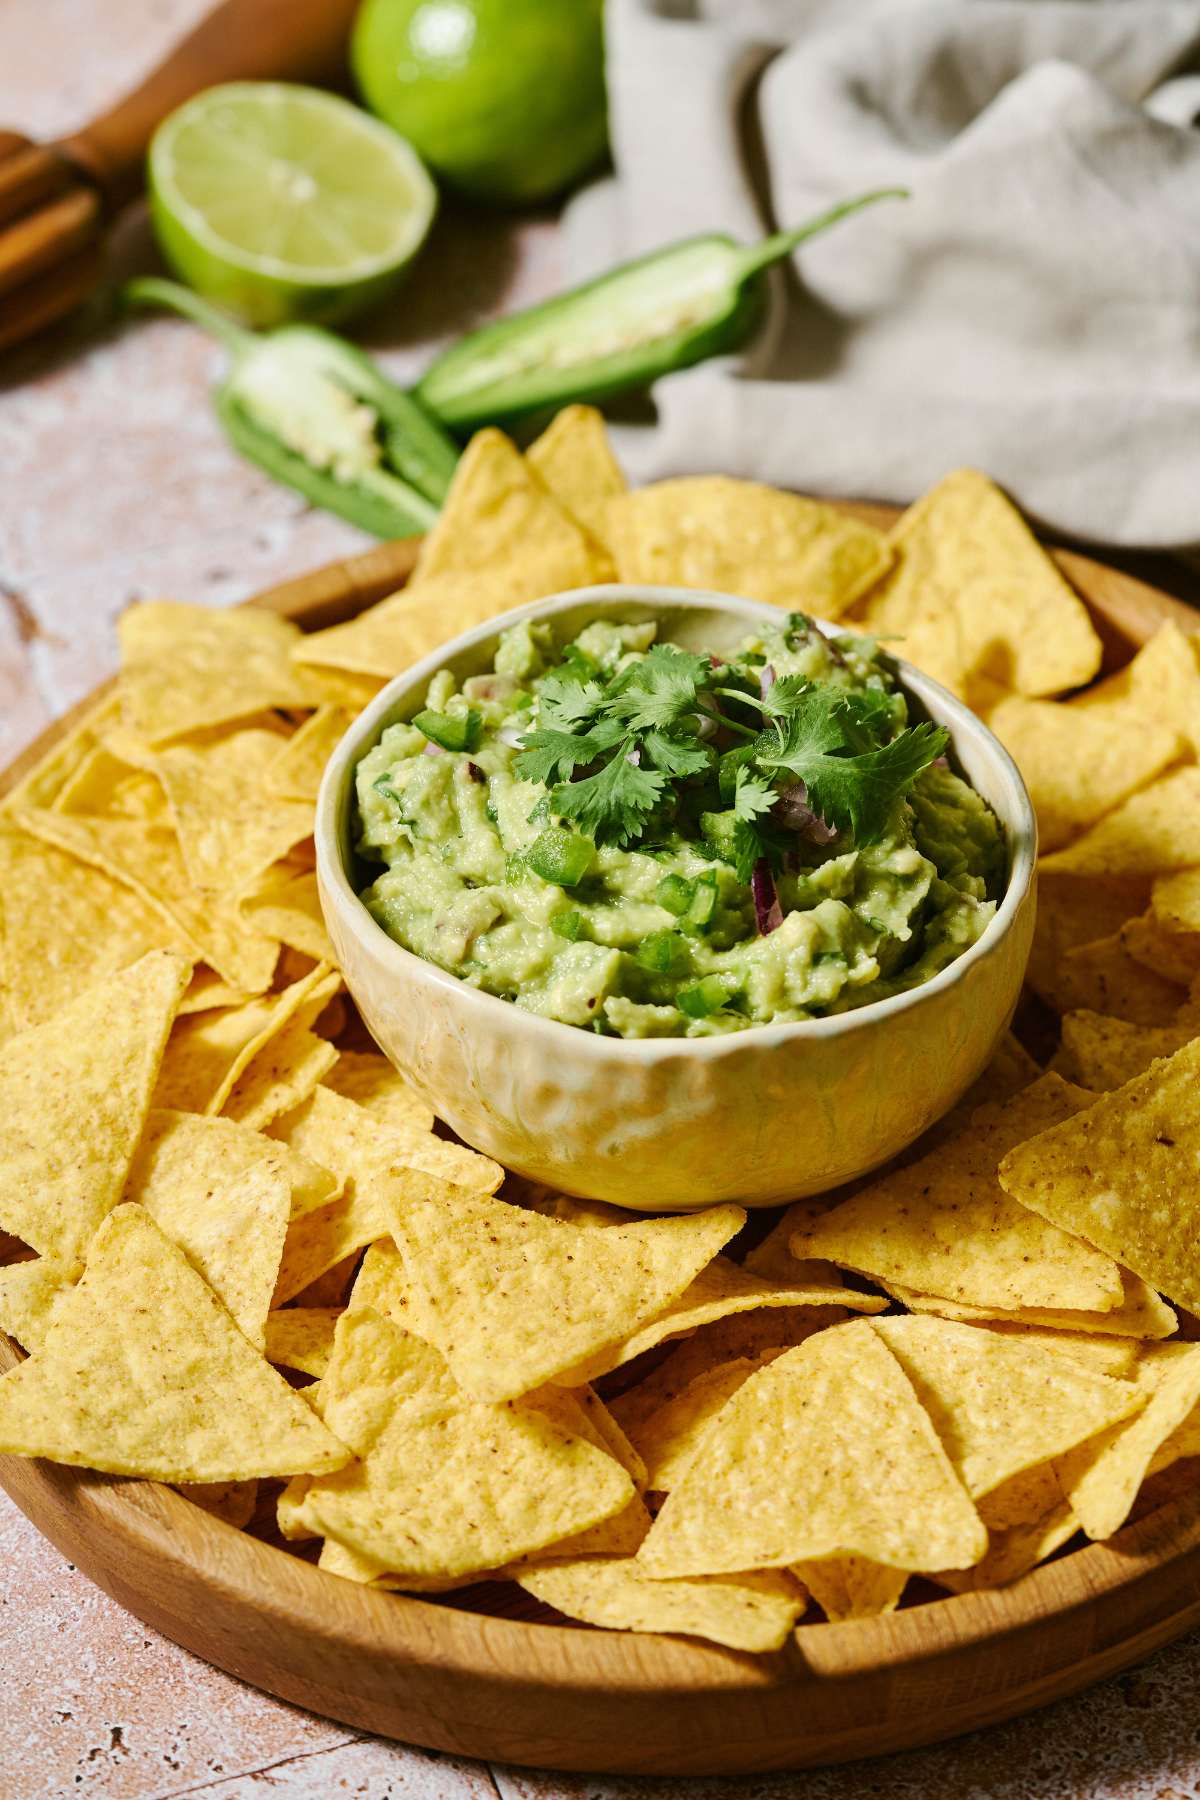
[155,729,313,895]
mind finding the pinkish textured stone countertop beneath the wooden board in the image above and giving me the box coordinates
[0,0,1200,1800]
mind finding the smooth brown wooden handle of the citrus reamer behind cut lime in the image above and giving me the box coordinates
[58,0,358,205]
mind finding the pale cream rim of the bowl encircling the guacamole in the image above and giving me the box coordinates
[313,581,1038,1062]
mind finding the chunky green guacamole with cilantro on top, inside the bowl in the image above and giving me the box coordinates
[356,614,1006,1039]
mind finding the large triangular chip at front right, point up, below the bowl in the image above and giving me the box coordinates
[639,1319,988,1577]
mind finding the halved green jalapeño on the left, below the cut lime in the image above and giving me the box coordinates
[124,277,459,538]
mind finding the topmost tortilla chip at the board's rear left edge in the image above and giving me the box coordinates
[117,599,311,743]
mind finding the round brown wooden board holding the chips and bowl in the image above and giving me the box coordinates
[0,506,1200,1775]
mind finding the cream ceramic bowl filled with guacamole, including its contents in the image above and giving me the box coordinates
[318,587,1034,1206]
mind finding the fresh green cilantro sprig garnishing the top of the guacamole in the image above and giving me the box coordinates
[516,621,948,867]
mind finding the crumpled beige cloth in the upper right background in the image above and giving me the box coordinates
[567,0,1200,545]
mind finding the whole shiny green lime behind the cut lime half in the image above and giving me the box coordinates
[351,0,608,205]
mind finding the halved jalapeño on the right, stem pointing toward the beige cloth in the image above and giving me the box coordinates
[414,187,905,430]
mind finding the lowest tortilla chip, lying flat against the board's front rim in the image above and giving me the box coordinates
[518,1557,808,1652]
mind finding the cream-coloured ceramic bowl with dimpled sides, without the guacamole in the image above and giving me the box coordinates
[317,587,1036,1211]
